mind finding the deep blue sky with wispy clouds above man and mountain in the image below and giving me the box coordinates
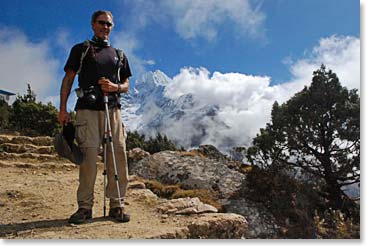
[0,0,360,104]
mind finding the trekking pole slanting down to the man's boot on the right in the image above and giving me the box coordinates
[103,92,122,213]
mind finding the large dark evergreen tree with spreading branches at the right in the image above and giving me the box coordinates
[247,65,360,209]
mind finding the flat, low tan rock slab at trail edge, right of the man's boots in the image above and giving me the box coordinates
[157,197,218,214]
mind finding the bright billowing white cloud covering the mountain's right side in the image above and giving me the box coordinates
[162,68,274,148]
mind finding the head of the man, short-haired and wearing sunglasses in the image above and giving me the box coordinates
[92,10,113,40]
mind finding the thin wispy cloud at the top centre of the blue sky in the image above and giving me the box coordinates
[162,0,265,40]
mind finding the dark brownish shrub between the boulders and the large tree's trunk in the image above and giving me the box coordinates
[236,166,322,238]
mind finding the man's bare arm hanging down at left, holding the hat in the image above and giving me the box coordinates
[59,69,76,125]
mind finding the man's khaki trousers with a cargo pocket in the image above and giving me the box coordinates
[75,108,128,209]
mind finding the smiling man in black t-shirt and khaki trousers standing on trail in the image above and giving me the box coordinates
[58,10,131,224]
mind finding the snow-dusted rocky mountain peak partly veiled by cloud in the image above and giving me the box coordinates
[121,70,250,151]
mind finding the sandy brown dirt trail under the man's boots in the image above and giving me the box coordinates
[0,159,192,239]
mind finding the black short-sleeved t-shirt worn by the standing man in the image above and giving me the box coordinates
[64,42,131,110]
